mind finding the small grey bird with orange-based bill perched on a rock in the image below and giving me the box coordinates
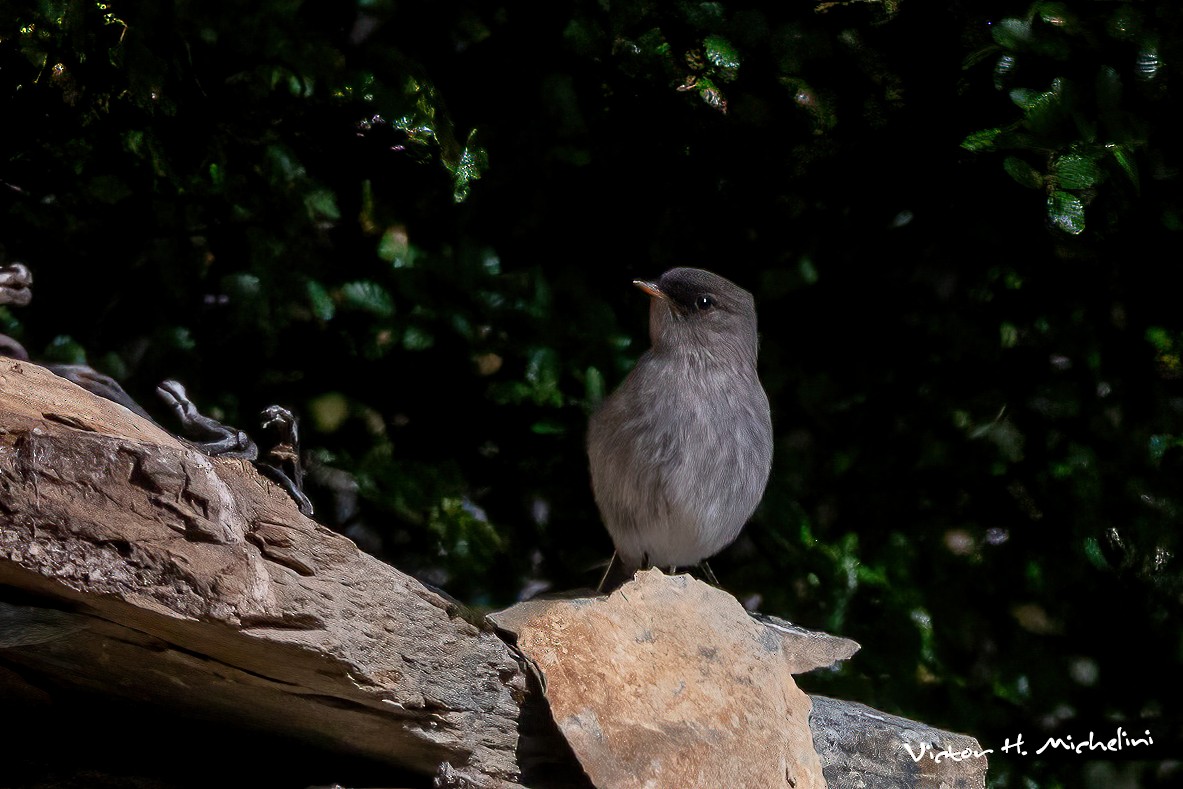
[588,269,772,584]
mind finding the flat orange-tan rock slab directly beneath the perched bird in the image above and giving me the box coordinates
[491,570,826,789]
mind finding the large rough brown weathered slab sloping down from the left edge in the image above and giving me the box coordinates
[0,360,526,783]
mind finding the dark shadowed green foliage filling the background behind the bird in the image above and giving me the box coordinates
[0,0,1183,787]
